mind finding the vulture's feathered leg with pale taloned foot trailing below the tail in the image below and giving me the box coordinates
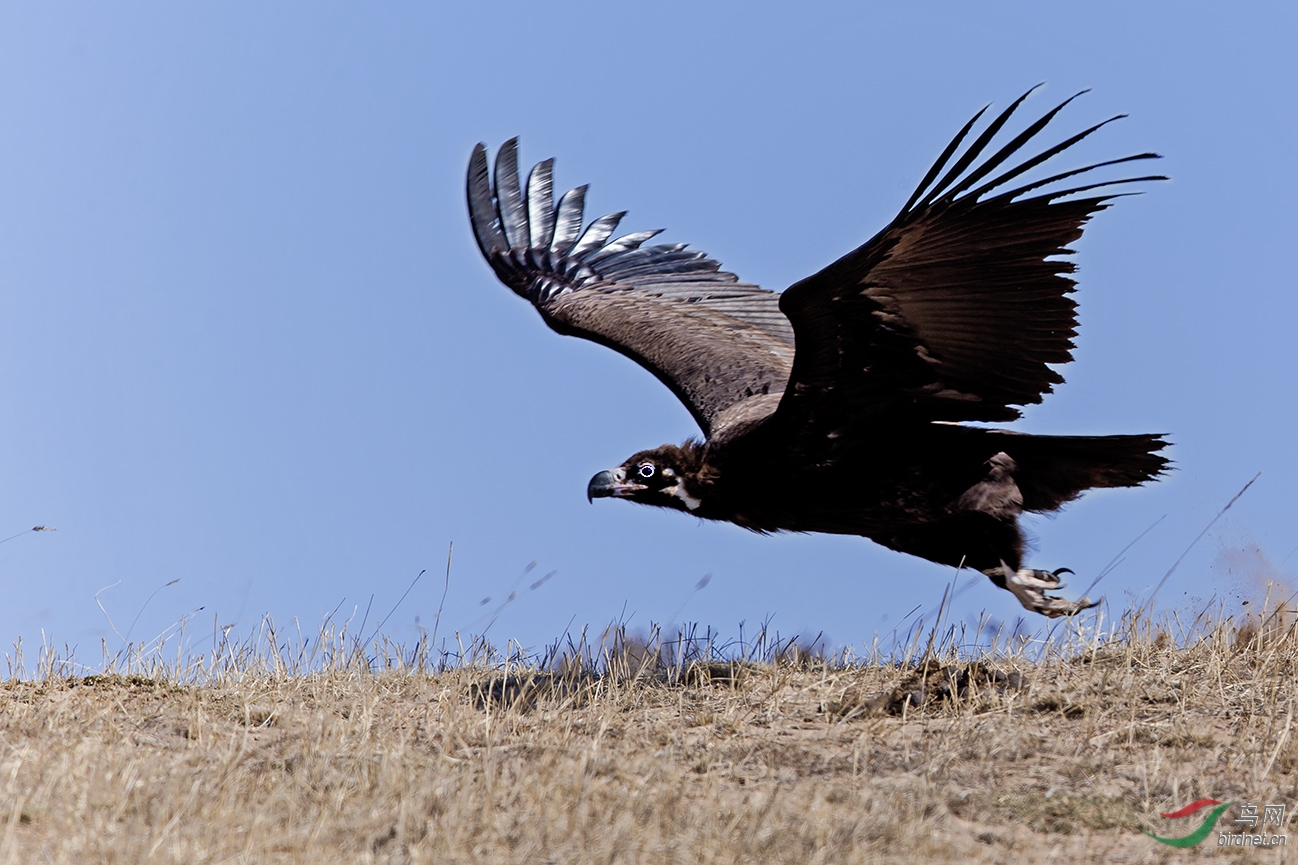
[955,452,1099,618]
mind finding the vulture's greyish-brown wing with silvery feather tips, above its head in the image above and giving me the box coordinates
[467,139,793,435]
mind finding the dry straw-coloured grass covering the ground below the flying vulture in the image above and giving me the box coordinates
[0,600,1298,864]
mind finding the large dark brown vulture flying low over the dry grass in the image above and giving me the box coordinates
[467,88,1168,617]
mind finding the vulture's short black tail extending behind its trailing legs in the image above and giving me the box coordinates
[1006,434,1171,512]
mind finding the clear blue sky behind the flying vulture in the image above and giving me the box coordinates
[0,3,1298,661]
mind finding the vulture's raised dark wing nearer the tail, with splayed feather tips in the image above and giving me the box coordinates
[778,91,1166,440]
